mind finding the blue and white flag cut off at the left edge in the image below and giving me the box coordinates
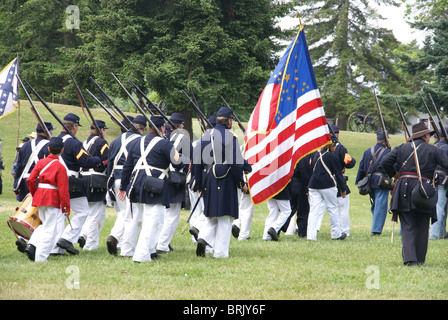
[0,58,19,119]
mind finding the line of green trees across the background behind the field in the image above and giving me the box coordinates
[0,0,448,128]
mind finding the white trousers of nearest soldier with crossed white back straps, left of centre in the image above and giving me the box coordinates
[132,203,166,262]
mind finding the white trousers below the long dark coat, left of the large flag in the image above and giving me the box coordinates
[198,216,233,258]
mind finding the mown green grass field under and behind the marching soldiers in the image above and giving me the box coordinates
[0,101,448,301]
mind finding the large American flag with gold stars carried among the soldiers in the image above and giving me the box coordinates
[244,26,331,204]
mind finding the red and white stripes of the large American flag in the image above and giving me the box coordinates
[245,84,330,204]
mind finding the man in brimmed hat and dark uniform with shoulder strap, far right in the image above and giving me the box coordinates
[382,122,448,266]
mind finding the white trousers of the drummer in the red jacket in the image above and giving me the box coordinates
[29,206,64,262]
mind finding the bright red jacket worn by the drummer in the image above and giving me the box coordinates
[26,154,70,212]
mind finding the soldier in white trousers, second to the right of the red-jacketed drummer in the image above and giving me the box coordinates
[78,120,109,250]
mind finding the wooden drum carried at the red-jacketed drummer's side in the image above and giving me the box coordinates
[8,194,42,240]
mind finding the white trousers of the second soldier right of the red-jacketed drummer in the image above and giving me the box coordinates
[81,201,106,250]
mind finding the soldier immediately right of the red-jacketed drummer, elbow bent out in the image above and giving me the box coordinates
[52,113,102,255]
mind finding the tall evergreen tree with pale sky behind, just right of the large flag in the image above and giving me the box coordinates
[302,0,401,128]
